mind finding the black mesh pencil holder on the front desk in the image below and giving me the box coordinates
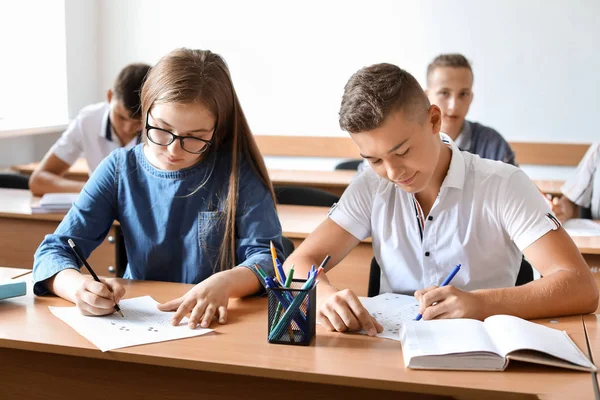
[267,279,317,346]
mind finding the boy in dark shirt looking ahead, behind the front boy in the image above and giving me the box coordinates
[425,54,516,165]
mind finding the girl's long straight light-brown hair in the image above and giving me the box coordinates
[141,48,275,271]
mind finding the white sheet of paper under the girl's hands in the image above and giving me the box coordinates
[48,296,212,351]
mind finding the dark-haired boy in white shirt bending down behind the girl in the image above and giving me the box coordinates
[29,64,150,196]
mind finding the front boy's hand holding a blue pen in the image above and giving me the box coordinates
[415,285,487,320]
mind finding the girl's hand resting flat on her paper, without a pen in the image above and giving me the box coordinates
[158,273,231,329]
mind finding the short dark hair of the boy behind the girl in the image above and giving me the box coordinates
[113,63,150,118]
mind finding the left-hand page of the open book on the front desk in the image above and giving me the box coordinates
[400,319,498,365]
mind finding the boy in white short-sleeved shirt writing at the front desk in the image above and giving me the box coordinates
[286,64,598,335]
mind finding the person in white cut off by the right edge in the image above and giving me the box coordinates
[552,143,600,222]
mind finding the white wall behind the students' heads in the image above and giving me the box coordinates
[98,0,600,142]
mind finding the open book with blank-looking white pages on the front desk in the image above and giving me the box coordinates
[400,315,596,371]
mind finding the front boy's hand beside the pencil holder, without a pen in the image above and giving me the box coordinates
[317,285,383,336]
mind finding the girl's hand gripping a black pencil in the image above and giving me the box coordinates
[75,277,125,315]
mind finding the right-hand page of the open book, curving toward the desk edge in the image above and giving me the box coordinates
[484,315,592,367]
